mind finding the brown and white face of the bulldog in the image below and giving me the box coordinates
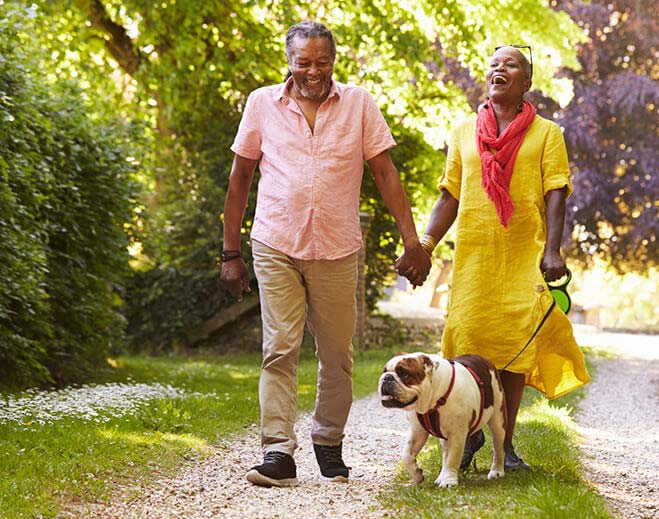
[379,353,434,409]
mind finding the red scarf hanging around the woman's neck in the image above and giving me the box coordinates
[476,101,535,227]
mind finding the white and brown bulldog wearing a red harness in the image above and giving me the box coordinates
[379,352,506,487]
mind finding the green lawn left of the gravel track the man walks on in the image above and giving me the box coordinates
[0,344,400,519]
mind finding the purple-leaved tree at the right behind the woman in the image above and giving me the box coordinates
[547,0,659,272]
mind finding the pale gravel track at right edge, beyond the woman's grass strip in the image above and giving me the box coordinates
[575,333,659,519]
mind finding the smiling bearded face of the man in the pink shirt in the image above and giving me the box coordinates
[288,37,334,101]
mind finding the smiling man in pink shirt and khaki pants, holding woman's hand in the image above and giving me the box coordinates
[221,21,430,486]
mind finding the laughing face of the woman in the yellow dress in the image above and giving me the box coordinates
[485,47,531,105]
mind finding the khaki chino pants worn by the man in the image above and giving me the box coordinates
[252,241,357,456]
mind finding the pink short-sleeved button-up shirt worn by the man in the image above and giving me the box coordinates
[231,80,396,260]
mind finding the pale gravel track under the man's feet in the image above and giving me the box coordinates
[61,396,407,519]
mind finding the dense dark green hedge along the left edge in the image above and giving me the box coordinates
[0,6,137,384]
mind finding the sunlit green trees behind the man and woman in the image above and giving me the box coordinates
[29,0,580,348]
